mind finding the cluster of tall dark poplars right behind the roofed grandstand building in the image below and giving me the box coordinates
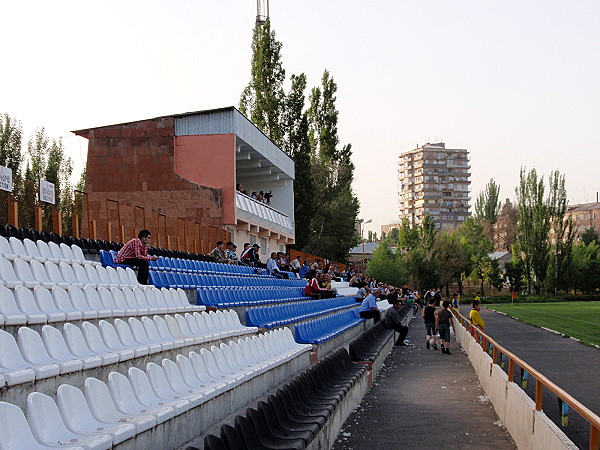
[239,21,359,261]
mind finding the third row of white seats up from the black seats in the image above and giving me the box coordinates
[0,285,206,325]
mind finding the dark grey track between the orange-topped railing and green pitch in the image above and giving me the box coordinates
[474,304,600,448]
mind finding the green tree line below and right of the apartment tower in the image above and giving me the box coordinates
[366,168,600,295]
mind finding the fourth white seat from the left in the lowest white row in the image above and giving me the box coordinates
[83,378,156,434]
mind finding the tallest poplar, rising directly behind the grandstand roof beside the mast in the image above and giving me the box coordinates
[240,20,285,147]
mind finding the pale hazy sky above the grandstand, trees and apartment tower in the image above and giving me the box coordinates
[0,0,600,233]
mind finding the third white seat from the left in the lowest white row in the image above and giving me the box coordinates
[56,384,136,445]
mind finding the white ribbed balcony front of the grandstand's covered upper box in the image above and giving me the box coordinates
[235,192,294,236]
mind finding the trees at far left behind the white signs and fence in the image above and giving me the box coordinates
[0,113,85,233]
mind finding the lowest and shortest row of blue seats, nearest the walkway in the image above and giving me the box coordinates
[295,307,365,344]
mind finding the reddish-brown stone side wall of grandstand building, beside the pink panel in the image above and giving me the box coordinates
[80,118,223,240]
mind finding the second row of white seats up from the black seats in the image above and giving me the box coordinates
[0,311,251,387]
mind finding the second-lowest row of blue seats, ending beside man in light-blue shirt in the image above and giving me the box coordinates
[246,297,356,328]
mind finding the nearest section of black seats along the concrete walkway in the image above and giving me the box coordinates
[199,349,366,450]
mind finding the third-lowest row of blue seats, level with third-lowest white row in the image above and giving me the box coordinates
[197,286,311,308]
